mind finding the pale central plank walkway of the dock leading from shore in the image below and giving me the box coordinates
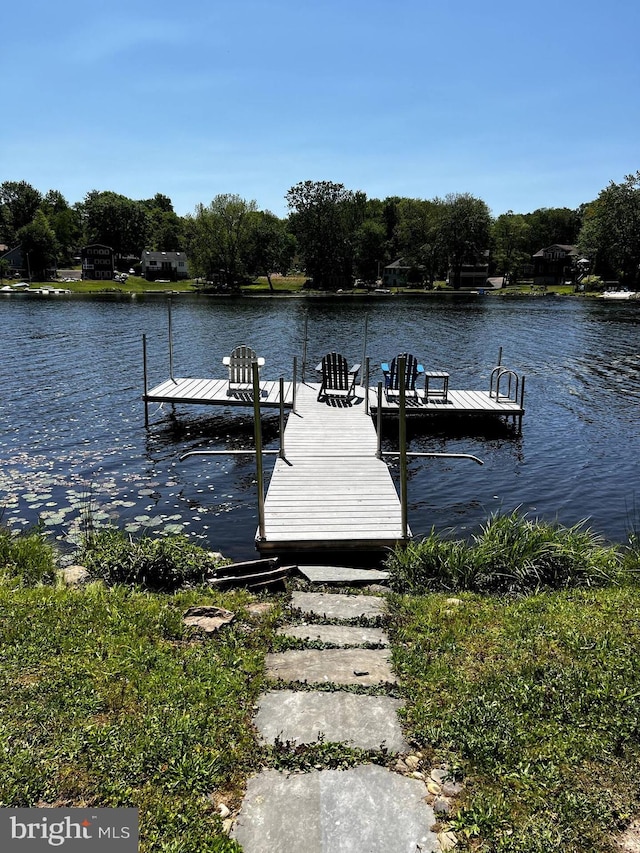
[256,384,402,554]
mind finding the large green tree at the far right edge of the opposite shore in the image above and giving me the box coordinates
[578,171,640,288]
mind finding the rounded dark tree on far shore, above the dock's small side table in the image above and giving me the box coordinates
[441,193,491,289]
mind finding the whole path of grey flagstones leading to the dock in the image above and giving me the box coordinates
[232,567,442,853]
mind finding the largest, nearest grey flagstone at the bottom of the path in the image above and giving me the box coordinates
[232,764,440,853]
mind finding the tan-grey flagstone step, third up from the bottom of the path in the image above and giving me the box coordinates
[266,649,397,687]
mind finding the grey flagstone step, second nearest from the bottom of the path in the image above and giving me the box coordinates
[255,690,409,753]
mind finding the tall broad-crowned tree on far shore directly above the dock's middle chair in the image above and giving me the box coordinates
[286,181,363,289]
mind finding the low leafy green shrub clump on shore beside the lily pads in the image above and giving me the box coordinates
[79,527,226,592]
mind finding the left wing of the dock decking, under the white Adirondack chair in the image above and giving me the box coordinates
[143,379,293,408]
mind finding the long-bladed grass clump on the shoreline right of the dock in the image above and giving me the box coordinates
[387,510,628,593]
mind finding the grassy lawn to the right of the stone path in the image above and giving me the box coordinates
[392,587,640,853]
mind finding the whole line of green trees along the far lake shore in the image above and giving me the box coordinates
[0,171,640,289]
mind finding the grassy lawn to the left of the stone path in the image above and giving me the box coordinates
[0,583,278,853]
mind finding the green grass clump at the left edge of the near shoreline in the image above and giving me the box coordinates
[0,525,56,586]
